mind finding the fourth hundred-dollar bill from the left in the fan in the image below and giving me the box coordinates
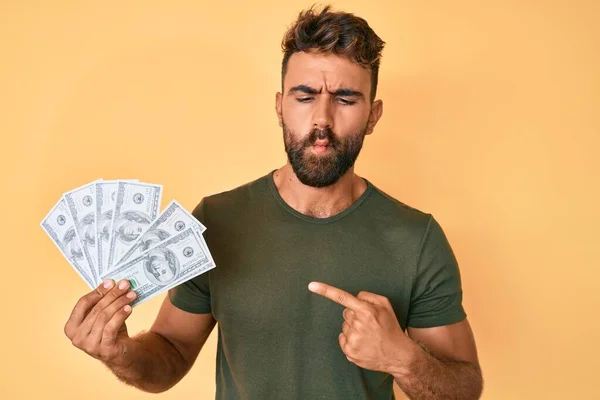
[104,181,162,271]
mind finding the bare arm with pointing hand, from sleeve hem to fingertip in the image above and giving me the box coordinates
[309,282,483,400]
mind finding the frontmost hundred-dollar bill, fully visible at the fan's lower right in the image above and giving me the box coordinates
[102,226,215,307]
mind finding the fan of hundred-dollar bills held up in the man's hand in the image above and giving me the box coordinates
[41,179,215,306]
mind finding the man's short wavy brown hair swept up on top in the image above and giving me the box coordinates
[281,5,385,101]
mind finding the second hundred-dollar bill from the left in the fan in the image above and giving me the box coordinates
[64,182,99,282]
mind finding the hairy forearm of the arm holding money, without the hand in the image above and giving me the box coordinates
[105,332,191,393]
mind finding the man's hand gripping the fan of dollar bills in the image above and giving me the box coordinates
[65,280,136,364]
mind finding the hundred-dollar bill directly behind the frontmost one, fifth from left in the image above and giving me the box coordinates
[116,200,206,265]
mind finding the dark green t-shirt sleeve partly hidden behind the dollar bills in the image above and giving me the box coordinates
[168,199,211,314]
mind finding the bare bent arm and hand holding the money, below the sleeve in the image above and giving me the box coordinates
[65,281,216,393]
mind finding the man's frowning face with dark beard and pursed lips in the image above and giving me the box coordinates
[276,52,381,187]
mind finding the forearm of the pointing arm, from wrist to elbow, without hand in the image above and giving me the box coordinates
[392,342,483,400]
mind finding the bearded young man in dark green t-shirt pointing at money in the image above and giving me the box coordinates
[65,7,482,400]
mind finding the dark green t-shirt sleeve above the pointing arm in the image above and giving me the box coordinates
[407,216,467,328]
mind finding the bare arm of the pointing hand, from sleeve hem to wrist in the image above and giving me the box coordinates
[392,319,483,400]
